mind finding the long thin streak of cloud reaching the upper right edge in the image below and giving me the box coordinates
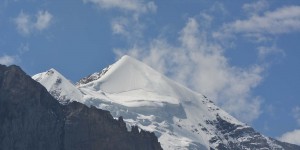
[222,6,300,35]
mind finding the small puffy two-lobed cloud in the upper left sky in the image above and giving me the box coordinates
[14,11,53,35]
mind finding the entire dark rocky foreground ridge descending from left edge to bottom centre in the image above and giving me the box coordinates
[0,65,161,150]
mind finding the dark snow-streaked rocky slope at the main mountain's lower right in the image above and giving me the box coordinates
[210,116,300,150]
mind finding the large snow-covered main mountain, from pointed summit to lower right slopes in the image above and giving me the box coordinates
[32,56,300,150]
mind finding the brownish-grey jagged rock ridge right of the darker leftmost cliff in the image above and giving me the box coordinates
[64,102,161,150]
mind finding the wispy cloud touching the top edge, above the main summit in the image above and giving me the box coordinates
[83,0,157,43]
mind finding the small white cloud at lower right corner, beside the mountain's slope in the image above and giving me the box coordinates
[277,129,300,145]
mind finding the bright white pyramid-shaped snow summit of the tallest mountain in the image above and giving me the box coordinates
[77,55,209,107]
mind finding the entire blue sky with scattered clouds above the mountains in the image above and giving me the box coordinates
[0,0,300,144]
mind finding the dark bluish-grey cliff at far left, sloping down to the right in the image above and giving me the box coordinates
[0,65,64,150]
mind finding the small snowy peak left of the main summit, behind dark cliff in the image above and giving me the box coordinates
[32,68,82,104]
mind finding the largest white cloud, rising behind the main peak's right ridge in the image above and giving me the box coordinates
[116,18,264,122]
